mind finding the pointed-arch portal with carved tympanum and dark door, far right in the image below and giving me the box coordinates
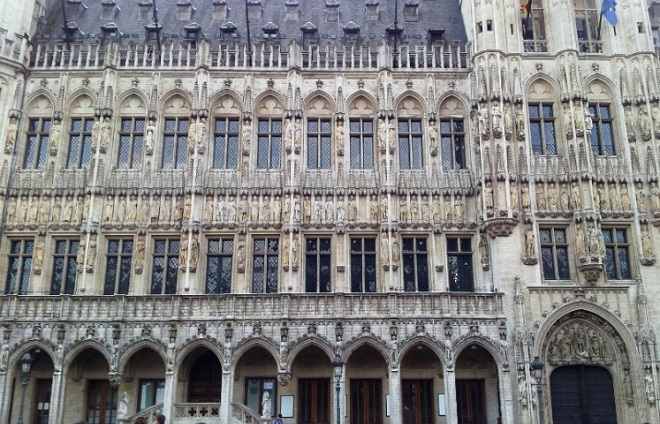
[542,310,634,424]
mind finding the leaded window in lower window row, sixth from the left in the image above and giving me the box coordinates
[252,237,279,293]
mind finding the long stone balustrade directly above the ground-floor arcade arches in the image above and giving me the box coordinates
[0,292,504,322]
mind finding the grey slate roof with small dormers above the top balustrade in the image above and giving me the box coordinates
[33,0,467,45]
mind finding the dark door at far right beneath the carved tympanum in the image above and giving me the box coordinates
[550,365,617,424]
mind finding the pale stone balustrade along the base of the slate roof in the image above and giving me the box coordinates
[30,41,470,71]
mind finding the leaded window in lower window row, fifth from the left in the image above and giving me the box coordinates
[206,238,234,294]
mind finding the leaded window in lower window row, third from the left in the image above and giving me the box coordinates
[103,240,133,295]
